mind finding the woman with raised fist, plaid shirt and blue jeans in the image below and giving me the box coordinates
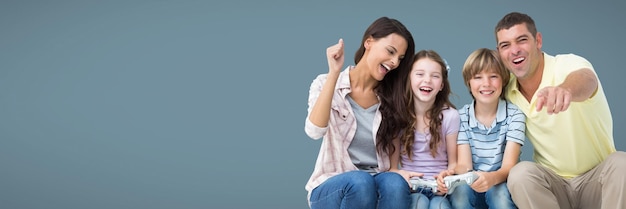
[305,17,415,209]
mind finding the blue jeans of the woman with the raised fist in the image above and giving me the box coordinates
[310,171,411,209]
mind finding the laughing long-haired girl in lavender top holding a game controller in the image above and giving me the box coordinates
[391,50,459,209]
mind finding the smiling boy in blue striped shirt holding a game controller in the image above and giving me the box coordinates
[440,48,526,209]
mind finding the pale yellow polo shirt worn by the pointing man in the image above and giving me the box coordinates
[506,53,615,178]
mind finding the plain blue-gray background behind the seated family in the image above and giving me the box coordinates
[0,0,626,209]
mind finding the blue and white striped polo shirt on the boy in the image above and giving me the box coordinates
[457,99,526,171]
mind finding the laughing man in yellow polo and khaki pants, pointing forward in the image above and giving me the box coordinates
[495,12,626,209]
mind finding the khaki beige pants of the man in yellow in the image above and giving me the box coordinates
[507,152,626,209]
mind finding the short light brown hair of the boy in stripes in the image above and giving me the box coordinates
[463,48,511,99]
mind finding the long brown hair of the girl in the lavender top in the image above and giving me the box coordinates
[400,50,456,159]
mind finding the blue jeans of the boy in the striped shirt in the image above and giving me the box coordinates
[450,182,517,209]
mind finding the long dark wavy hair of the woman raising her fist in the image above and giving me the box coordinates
[354,17,415,154]
